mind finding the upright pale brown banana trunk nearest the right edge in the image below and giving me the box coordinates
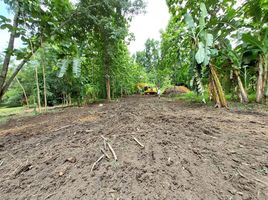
[256,54,264,103]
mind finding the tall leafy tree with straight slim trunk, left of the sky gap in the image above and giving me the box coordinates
[72,0,144,100]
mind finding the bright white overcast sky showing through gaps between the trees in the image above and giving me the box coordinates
[0,0,169,53]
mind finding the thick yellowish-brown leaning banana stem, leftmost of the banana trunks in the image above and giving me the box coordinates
[210,65,227,107]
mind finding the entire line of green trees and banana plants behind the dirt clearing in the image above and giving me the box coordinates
[0,0,268,107]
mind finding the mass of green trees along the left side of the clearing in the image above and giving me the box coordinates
[0,0,145,106]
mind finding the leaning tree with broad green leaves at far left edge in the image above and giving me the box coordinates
[0,0,71,100]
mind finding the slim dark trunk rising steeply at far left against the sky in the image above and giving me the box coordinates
[0,9,20,90]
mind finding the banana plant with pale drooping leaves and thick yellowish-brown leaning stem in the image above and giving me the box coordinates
[184,3,227,107]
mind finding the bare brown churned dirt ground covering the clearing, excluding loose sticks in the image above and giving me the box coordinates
[0,97,268,200]
